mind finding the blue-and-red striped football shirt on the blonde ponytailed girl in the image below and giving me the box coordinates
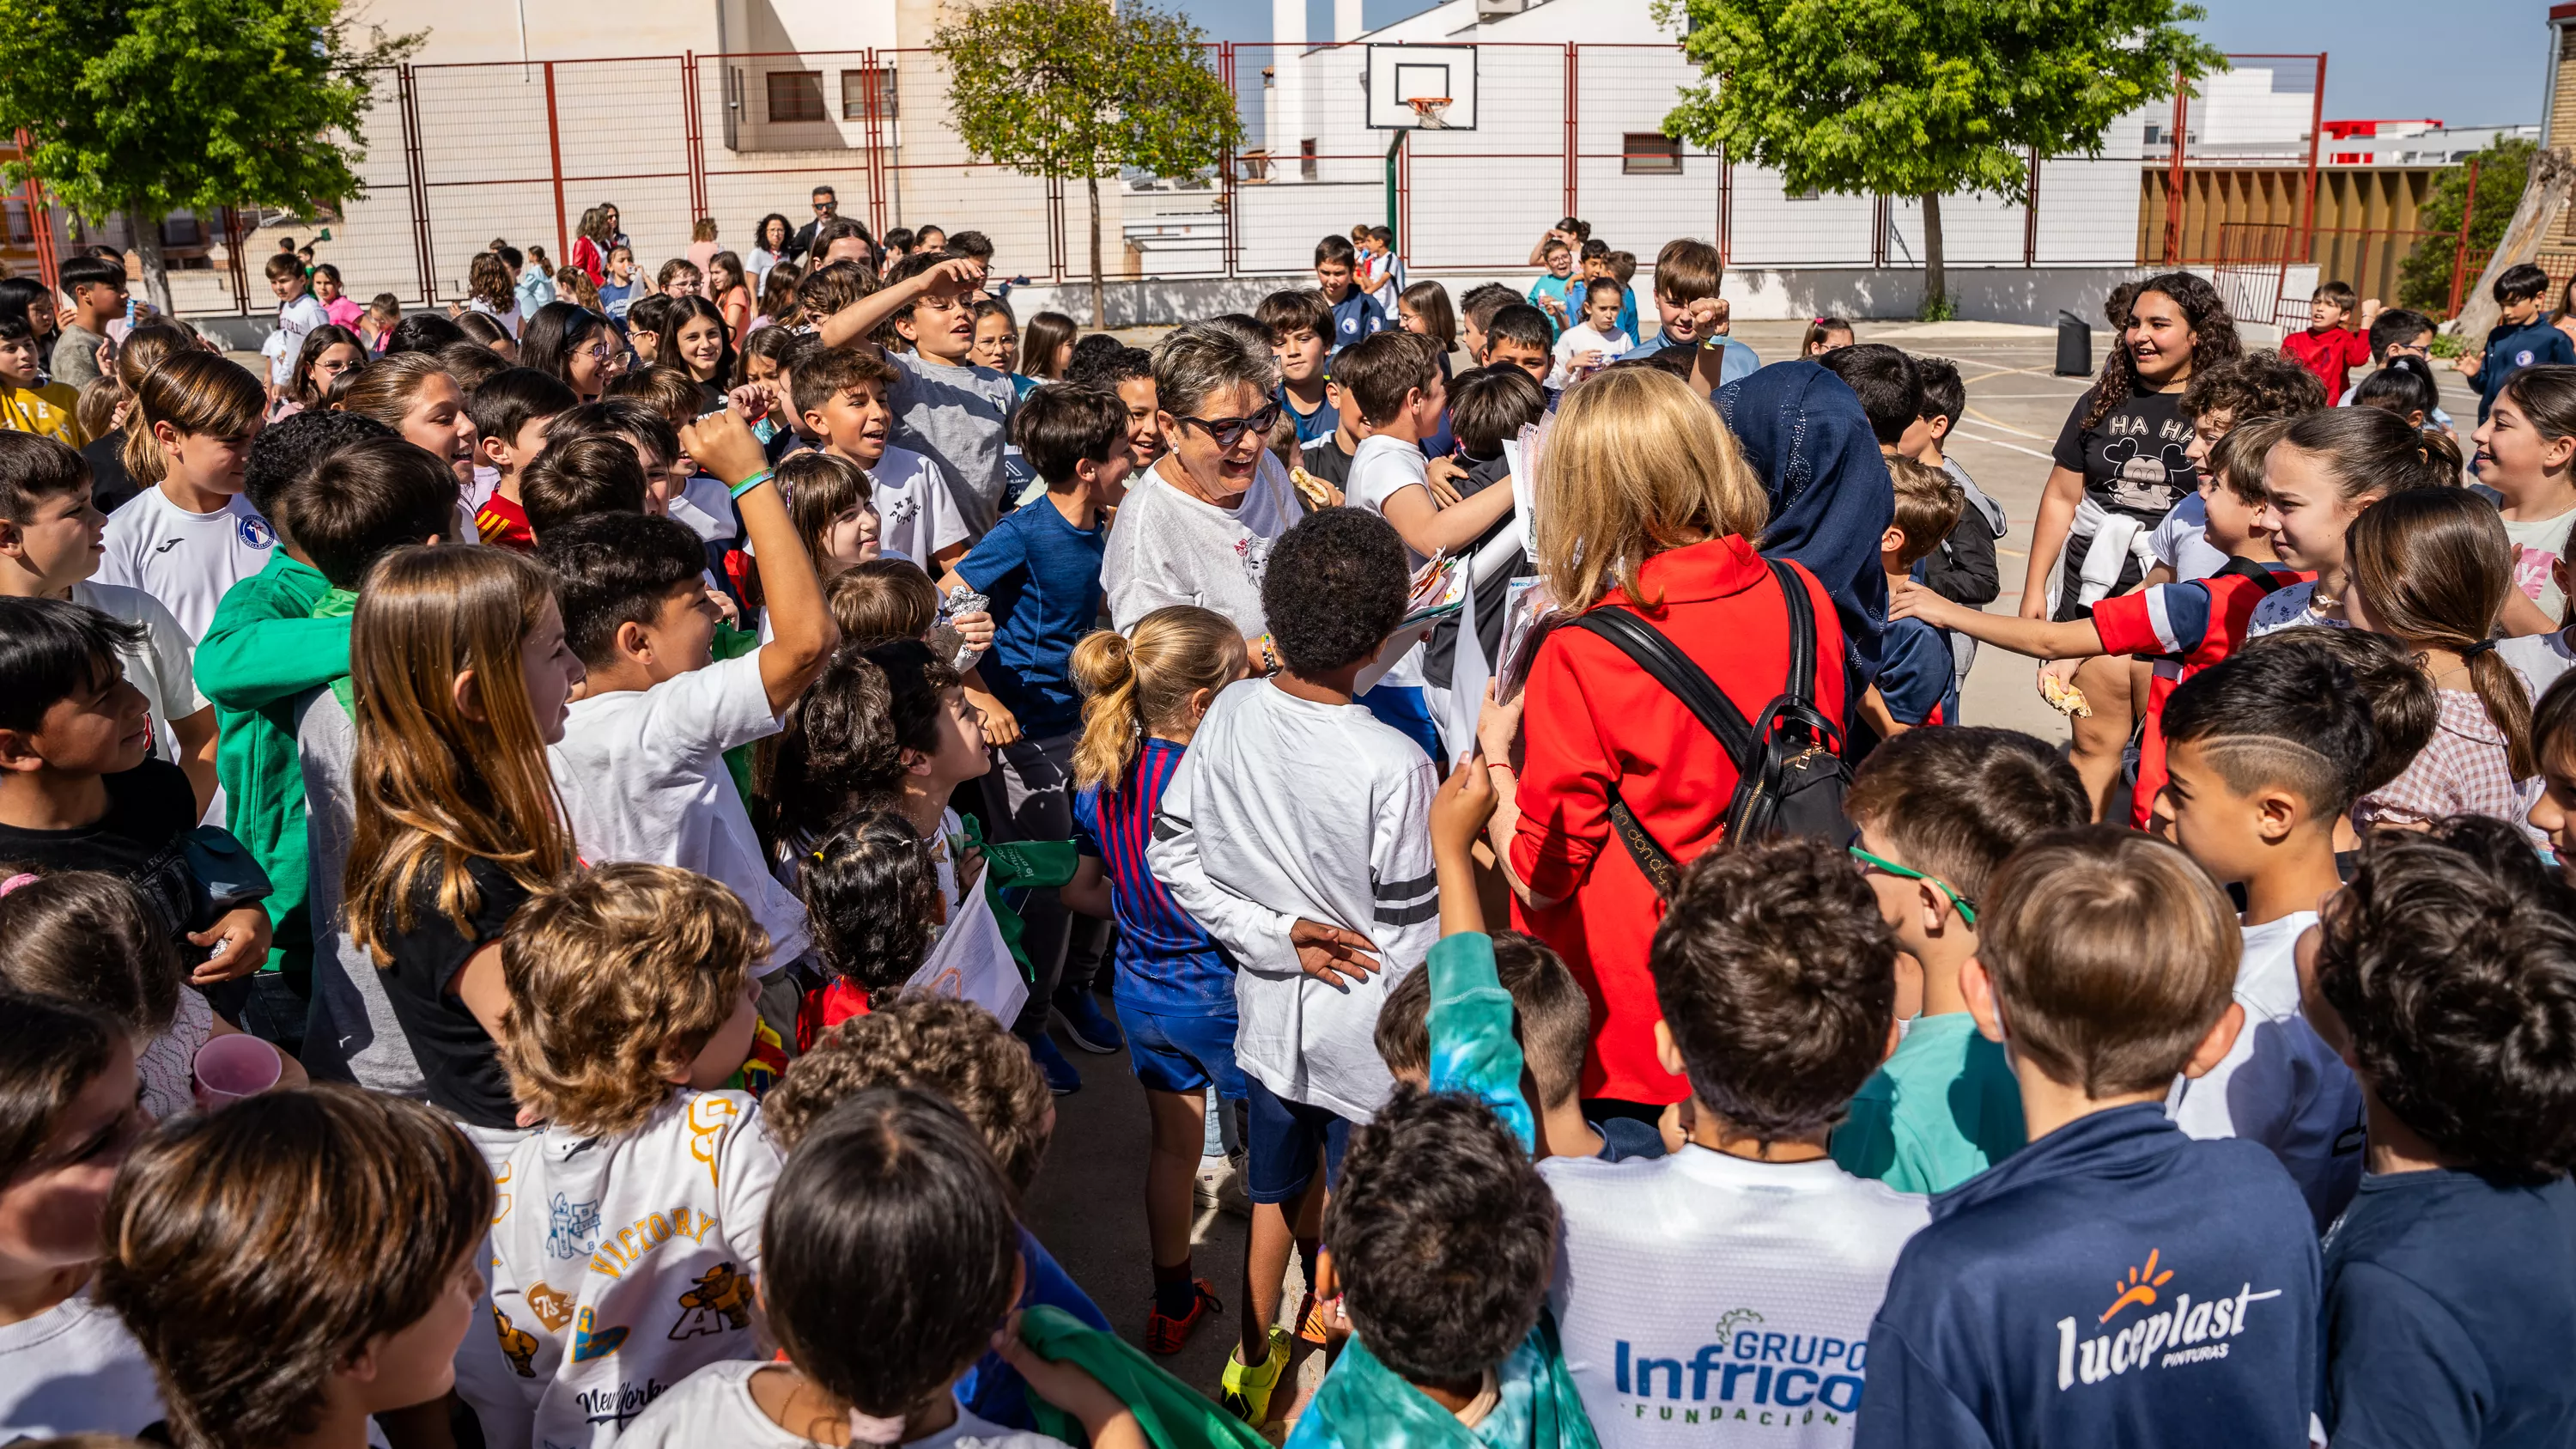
[1074,740,1234,1016]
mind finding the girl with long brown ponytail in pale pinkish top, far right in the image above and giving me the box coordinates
[2344,487,2540,831]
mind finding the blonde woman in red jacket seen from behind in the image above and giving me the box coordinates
[1479,368,1844,1106]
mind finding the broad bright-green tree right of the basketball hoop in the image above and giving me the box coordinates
[1656,0,2226,317]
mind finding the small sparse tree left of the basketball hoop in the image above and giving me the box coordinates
[930,0,1244,327]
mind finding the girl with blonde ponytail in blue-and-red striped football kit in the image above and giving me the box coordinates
[1064,603,1247,1354]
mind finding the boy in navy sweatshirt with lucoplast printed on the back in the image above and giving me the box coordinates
[1855,825,2329,1449]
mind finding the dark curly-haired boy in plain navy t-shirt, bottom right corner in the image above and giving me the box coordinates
[2306,825,2576,1449]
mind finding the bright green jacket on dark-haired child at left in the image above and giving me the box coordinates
[196,549,348,980]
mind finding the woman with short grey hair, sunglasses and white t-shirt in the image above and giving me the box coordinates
[1100,322,1301,673]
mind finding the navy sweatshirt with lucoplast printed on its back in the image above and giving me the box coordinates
[1855,1104,2321,1449]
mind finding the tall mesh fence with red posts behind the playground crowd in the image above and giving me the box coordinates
[10,41,2375,314]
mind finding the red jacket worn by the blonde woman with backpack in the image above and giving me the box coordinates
[1512,536,1844,1104]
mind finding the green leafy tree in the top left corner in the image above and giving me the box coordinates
[0,0,417,312]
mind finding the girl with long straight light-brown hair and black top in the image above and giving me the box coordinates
[343,546,582,1139]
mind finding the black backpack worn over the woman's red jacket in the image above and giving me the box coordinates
[1571,559,1852,900]
